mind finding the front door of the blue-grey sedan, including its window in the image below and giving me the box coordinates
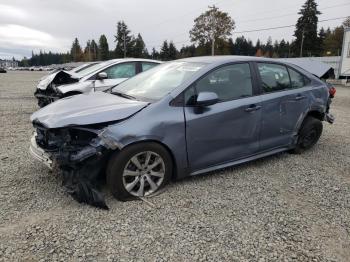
[184,63,261,172]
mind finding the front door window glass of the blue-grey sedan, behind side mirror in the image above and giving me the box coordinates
[196,63,253,101]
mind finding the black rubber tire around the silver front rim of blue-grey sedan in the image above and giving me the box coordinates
[106,142,173,201]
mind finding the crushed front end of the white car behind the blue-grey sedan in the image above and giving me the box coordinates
[34,71,79,107]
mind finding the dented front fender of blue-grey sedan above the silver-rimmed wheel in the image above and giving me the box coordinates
[99,98,188,178]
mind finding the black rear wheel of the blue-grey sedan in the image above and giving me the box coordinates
[291,116,323,154]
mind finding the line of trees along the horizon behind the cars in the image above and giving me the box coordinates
[21,0,350,66]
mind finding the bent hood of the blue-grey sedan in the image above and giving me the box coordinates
[30,92,148,128]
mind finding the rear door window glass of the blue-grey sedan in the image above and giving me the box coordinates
[258,63,290,93]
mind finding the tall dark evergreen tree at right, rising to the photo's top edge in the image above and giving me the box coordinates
[294,0,321,56]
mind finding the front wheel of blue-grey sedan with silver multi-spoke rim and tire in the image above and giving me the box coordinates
[107,143,173,200]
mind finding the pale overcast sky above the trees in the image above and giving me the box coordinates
[0,0,350,58]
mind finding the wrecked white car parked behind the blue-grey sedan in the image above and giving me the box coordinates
[34,58,162,107]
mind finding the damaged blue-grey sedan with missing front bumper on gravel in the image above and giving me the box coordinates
[30,56,334,208]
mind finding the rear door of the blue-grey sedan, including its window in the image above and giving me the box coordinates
[256,62,308,151]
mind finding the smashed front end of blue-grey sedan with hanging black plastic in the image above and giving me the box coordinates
[30,122,116,209]
